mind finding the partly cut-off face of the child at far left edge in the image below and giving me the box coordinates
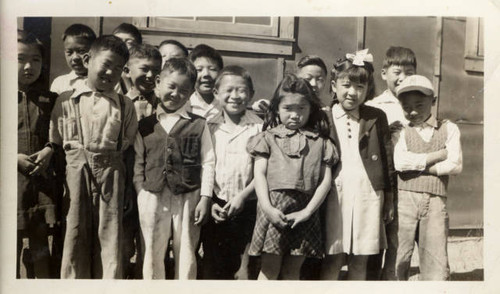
[17,42,42,90]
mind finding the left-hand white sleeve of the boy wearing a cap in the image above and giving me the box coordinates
[394,129,427,172]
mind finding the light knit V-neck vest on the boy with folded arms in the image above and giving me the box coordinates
[398,121,449,196]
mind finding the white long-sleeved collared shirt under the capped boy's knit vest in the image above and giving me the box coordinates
[393,115,462,176]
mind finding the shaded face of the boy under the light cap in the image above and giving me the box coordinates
[399,91,435,125]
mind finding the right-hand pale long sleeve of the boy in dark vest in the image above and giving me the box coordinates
[200,123,215,197]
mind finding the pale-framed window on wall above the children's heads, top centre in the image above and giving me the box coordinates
[133,16,295,56]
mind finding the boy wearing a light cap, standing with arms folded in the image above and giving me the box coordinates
[384,75,462,280]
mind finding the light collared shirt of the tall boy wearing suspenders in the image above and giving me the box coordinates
[49,85,137,152]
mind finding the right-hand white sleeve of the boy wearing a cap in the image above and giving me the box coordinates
[435,122,462,176]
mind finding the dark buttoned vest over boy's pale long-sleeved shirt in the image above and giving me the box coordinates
[139,113,205,195]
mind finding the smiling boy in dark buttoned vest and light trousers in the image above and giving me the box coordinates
[134,58,215,279]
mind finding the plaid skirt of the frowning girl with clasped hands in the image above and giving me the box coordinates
[248,190,324,258]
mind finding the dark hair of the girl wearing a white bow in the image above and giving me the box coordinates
[331,58,375,103]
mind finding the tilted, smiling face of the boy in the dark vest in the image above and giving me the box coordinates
[155,70,194,112]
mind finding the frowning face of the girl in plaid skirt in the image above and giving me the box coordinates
[278,93,311,130]
